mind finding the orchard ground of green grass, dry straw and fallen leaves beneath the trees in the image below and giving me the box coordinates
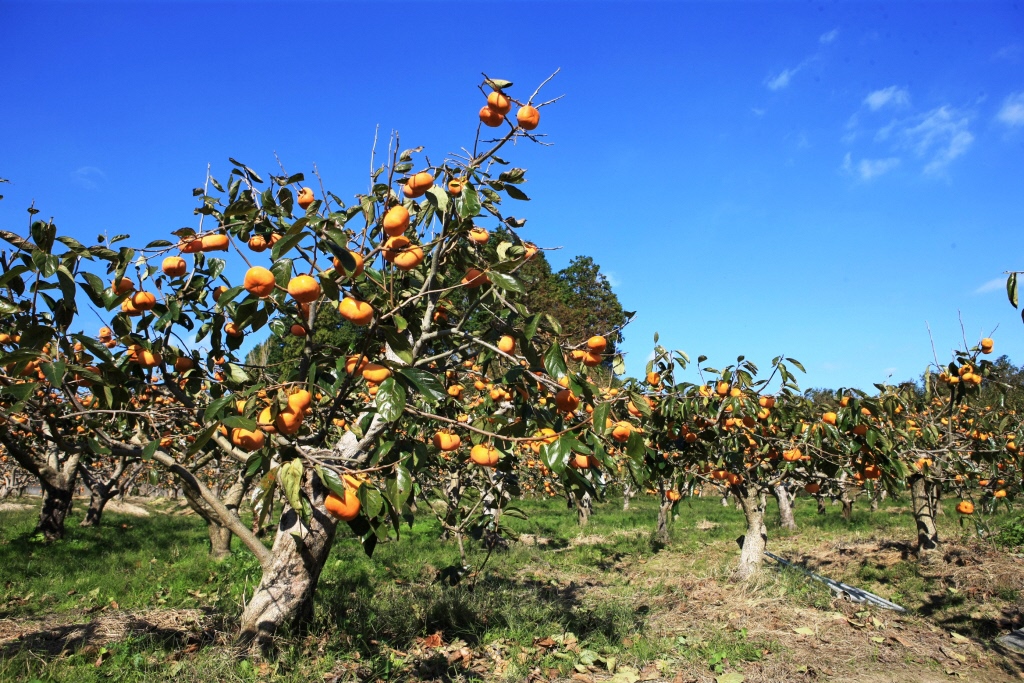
[0,491,1024,683]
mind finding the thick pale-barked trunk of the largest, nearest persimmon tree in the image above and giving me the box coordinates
[239,470,337,647]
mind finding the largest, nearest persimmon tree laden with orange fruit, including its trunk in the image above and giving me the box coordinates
[0,72,638,642]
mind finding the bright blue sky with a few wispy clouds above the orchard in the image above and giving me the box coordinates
[0,1,1024,388]
